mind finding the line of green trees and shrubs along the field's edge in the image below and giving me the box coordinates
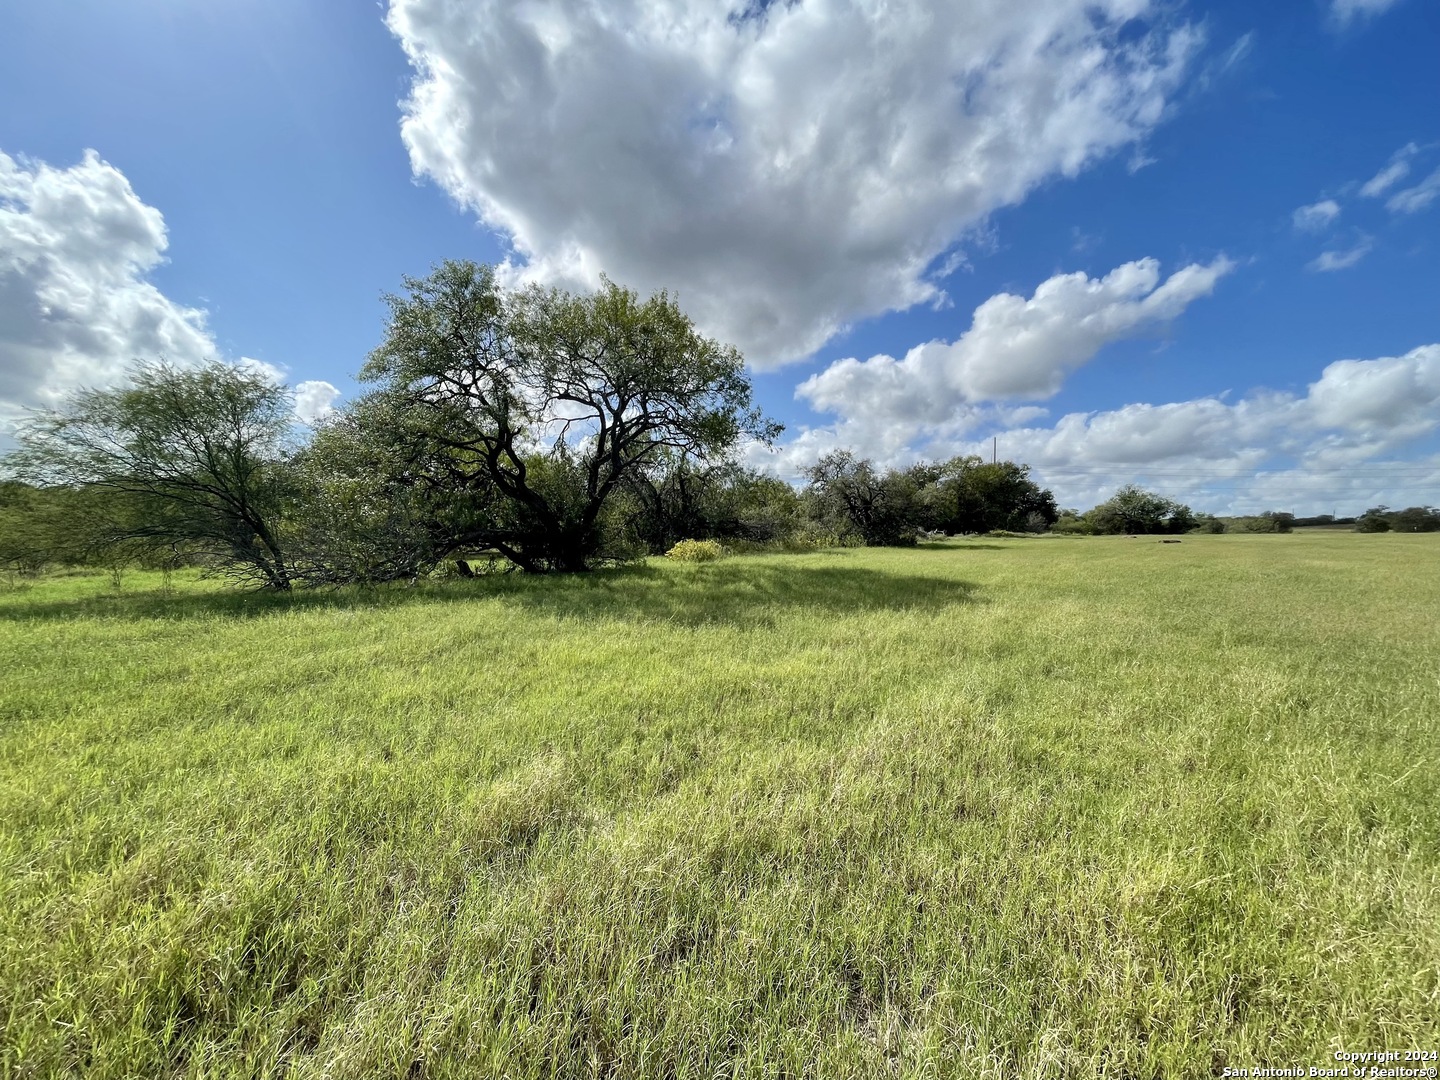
[0,262,1416,590]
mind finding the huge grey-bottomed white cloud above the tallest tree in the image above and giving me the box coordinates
[389,0,1200,367]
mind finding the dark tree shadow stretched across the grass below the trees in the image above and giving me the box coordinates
[0,560,975,626]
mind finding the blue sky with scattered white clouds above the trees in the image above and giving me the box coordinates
[0,0,1440,514]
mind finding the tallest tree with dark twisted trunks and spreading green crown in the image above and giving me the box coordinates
[351,262,780,572]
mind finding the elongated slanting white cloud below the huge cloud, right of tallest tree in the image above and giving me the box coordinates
[796,258,1234,426]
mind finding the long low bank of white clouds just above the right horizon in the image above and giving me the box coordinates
[750,344,1440,513]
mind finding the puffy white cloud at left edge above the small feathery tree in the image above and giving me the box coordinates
[0,151,217,413]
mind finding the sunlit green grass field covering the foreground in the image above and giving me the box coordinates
[0,533,1440,1080]
